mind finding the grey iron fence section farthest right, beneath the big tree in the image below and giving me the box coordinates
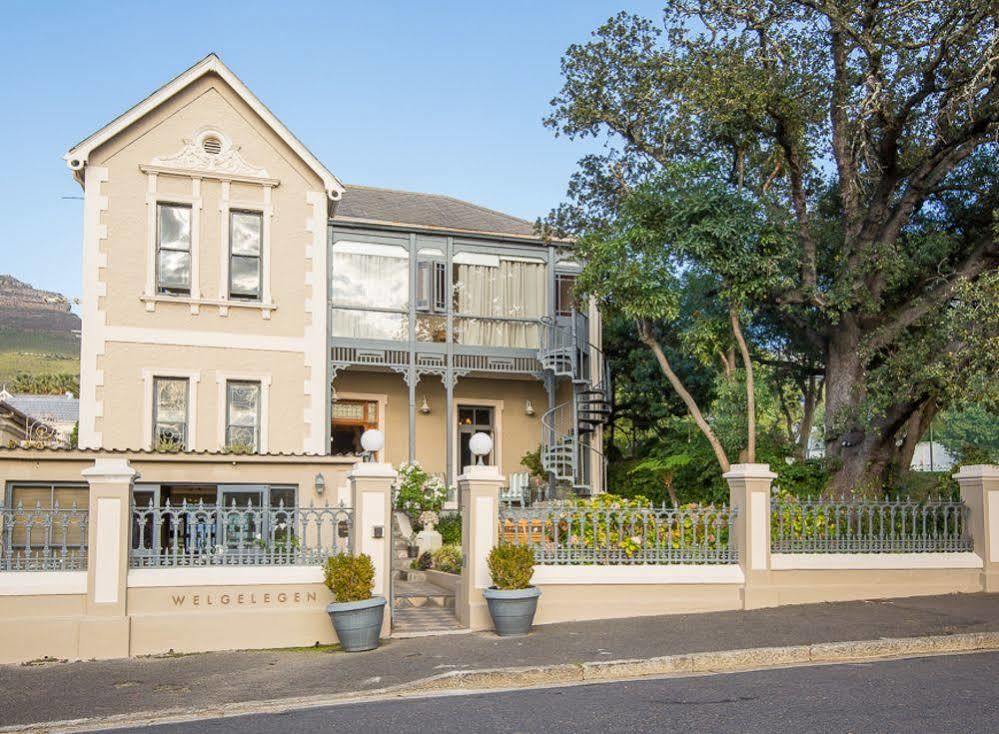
[770,497,973,553]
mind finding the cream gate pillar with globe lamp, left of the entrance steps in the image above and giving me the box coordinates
[347,463,397,637]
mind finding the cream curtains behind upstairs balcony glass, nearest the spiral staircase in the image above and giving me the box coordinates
[456,259,547,349]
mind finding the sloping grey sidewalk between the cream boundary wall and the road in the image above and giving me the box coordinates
[0,594,999,728]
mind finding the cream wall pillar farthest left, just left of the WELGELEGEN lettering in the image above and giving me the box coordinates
[79,459,138,660]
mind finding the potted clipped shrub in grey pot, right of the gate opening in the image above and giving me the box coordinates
[482,545,541,637]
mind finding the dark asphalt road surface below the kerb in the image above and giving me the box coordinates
[109,653,999,734]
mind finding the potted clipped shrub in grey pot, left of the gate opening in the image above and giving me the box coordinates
[326,554,385,652]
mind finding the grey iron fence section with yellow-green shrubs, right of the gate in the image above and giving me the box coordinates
[499,500,739,565]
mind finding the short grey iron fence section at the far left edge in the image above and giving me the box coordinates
[0,503,87,571]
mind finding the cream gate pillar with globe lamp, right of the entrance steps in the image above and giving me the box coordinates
[455,466,504,630]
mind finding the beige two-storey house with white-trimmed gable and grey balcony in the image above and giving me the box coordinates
[1,55,607,516]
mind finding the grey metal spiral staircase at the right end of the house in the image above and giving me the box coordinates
[538,317,611,495]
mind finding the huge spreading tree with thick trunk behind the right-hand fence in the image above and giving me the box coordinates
[546,0,999,491]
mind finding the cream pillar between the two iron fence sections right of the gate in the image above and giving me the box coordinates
[723,464,777,609]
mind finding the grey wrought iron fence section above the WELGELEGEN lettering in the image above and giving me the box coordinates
[129,502,353,568]
